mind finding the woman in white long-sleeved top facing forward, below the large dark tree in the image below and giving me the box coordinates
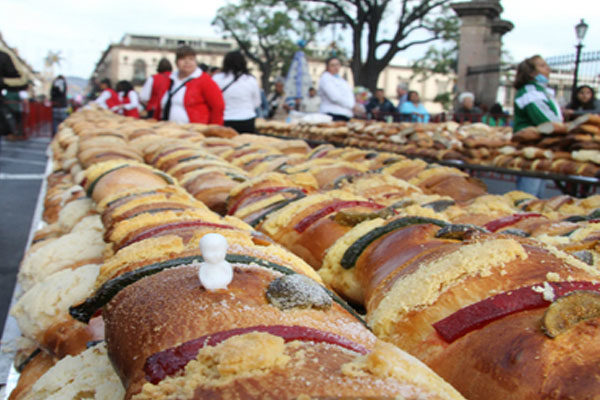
[319,57,354,121]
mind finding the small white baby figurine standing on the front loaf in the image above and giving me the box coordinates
[198,233,233,290]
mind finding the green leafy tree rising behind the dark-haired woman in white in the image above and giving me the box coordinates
[212,0,316,94]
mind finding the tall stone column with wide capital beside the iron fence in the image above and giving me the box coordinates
[451,0,513,107]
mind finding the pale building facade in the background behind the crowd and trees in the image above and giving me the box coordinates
[93,34,454,113]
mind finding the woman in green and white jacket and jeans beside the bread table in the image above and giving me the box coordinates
[513,55,563,197]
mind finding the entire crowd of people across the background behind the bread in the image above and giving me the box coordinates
[0,46,600,140]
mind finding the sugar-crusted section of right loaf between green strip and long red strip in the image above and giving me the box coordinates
[368,238,600,359]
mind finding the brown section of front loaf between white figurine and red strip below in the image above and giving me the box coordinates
[103,266,374,394]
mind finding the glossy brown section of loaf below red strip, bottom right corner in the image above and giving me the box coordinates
[428,309,600,400]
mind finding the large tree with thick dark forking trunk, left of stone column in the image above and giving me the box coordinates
[301,0,453,90]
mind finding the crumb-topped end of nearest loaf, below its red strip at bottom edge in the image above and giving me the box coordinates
[134,334,462,400]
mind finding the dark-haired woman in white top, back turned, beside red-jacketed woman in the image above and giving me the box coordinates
[213,51,260,133]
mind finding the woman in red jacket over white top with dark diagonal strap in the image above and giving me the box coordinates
[160,46,225,125]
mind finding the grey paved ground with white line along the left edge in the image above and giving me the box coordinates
[0,138,49,332]
